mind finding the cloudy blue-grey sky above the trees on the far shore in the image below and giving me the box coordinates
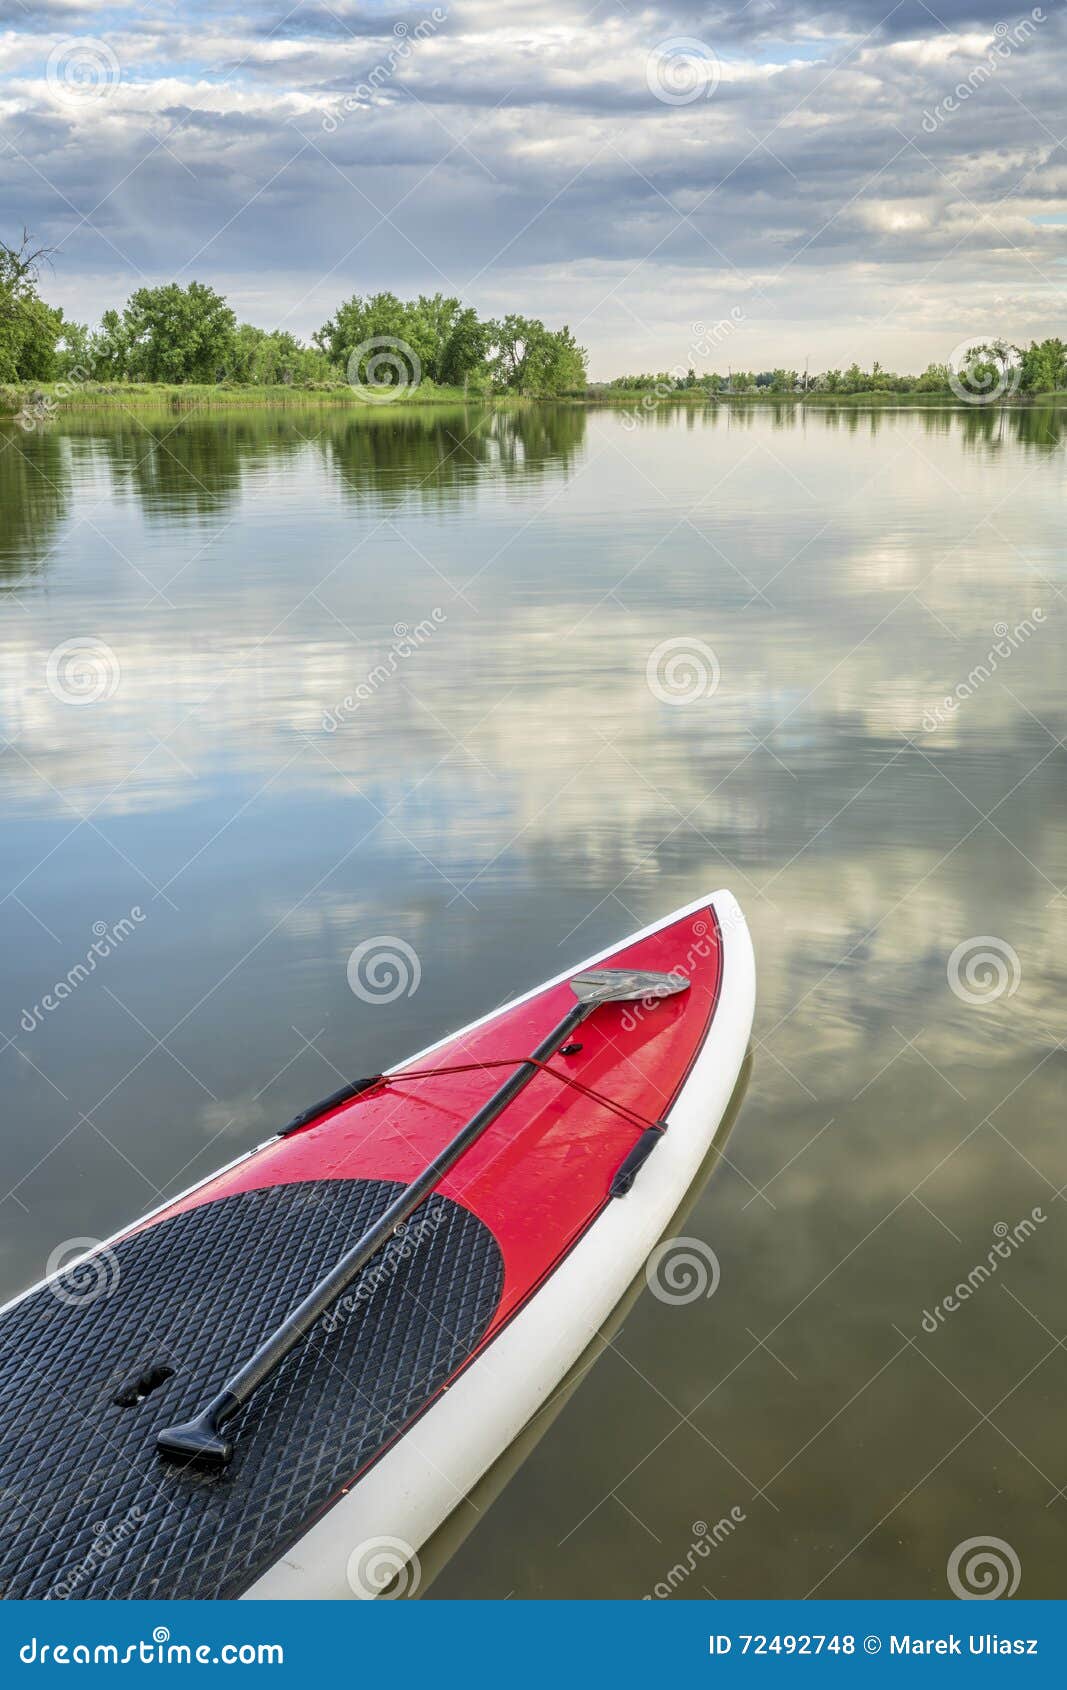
[0,0,1067,377]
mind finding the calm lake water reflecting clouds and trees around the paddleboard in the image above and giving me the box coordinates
[0,406,1067,1599]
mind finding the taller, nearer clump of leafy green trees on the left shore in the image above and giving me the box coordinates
[0,233,587,397]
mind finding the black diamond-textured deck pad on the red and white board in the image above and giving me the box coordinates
[0,1180,504,1599]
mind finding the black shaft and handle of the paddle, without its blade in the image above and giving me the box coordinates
[159,1004,597,1464]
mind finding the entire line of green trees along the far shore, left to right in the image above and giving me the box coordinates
[0,233,1067,397]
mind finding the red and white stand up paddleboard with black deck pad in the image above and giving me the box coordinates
[0,892,754,1599]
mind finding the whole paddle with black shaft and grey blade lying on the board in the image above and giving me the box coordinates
[156,968,688,1467]
